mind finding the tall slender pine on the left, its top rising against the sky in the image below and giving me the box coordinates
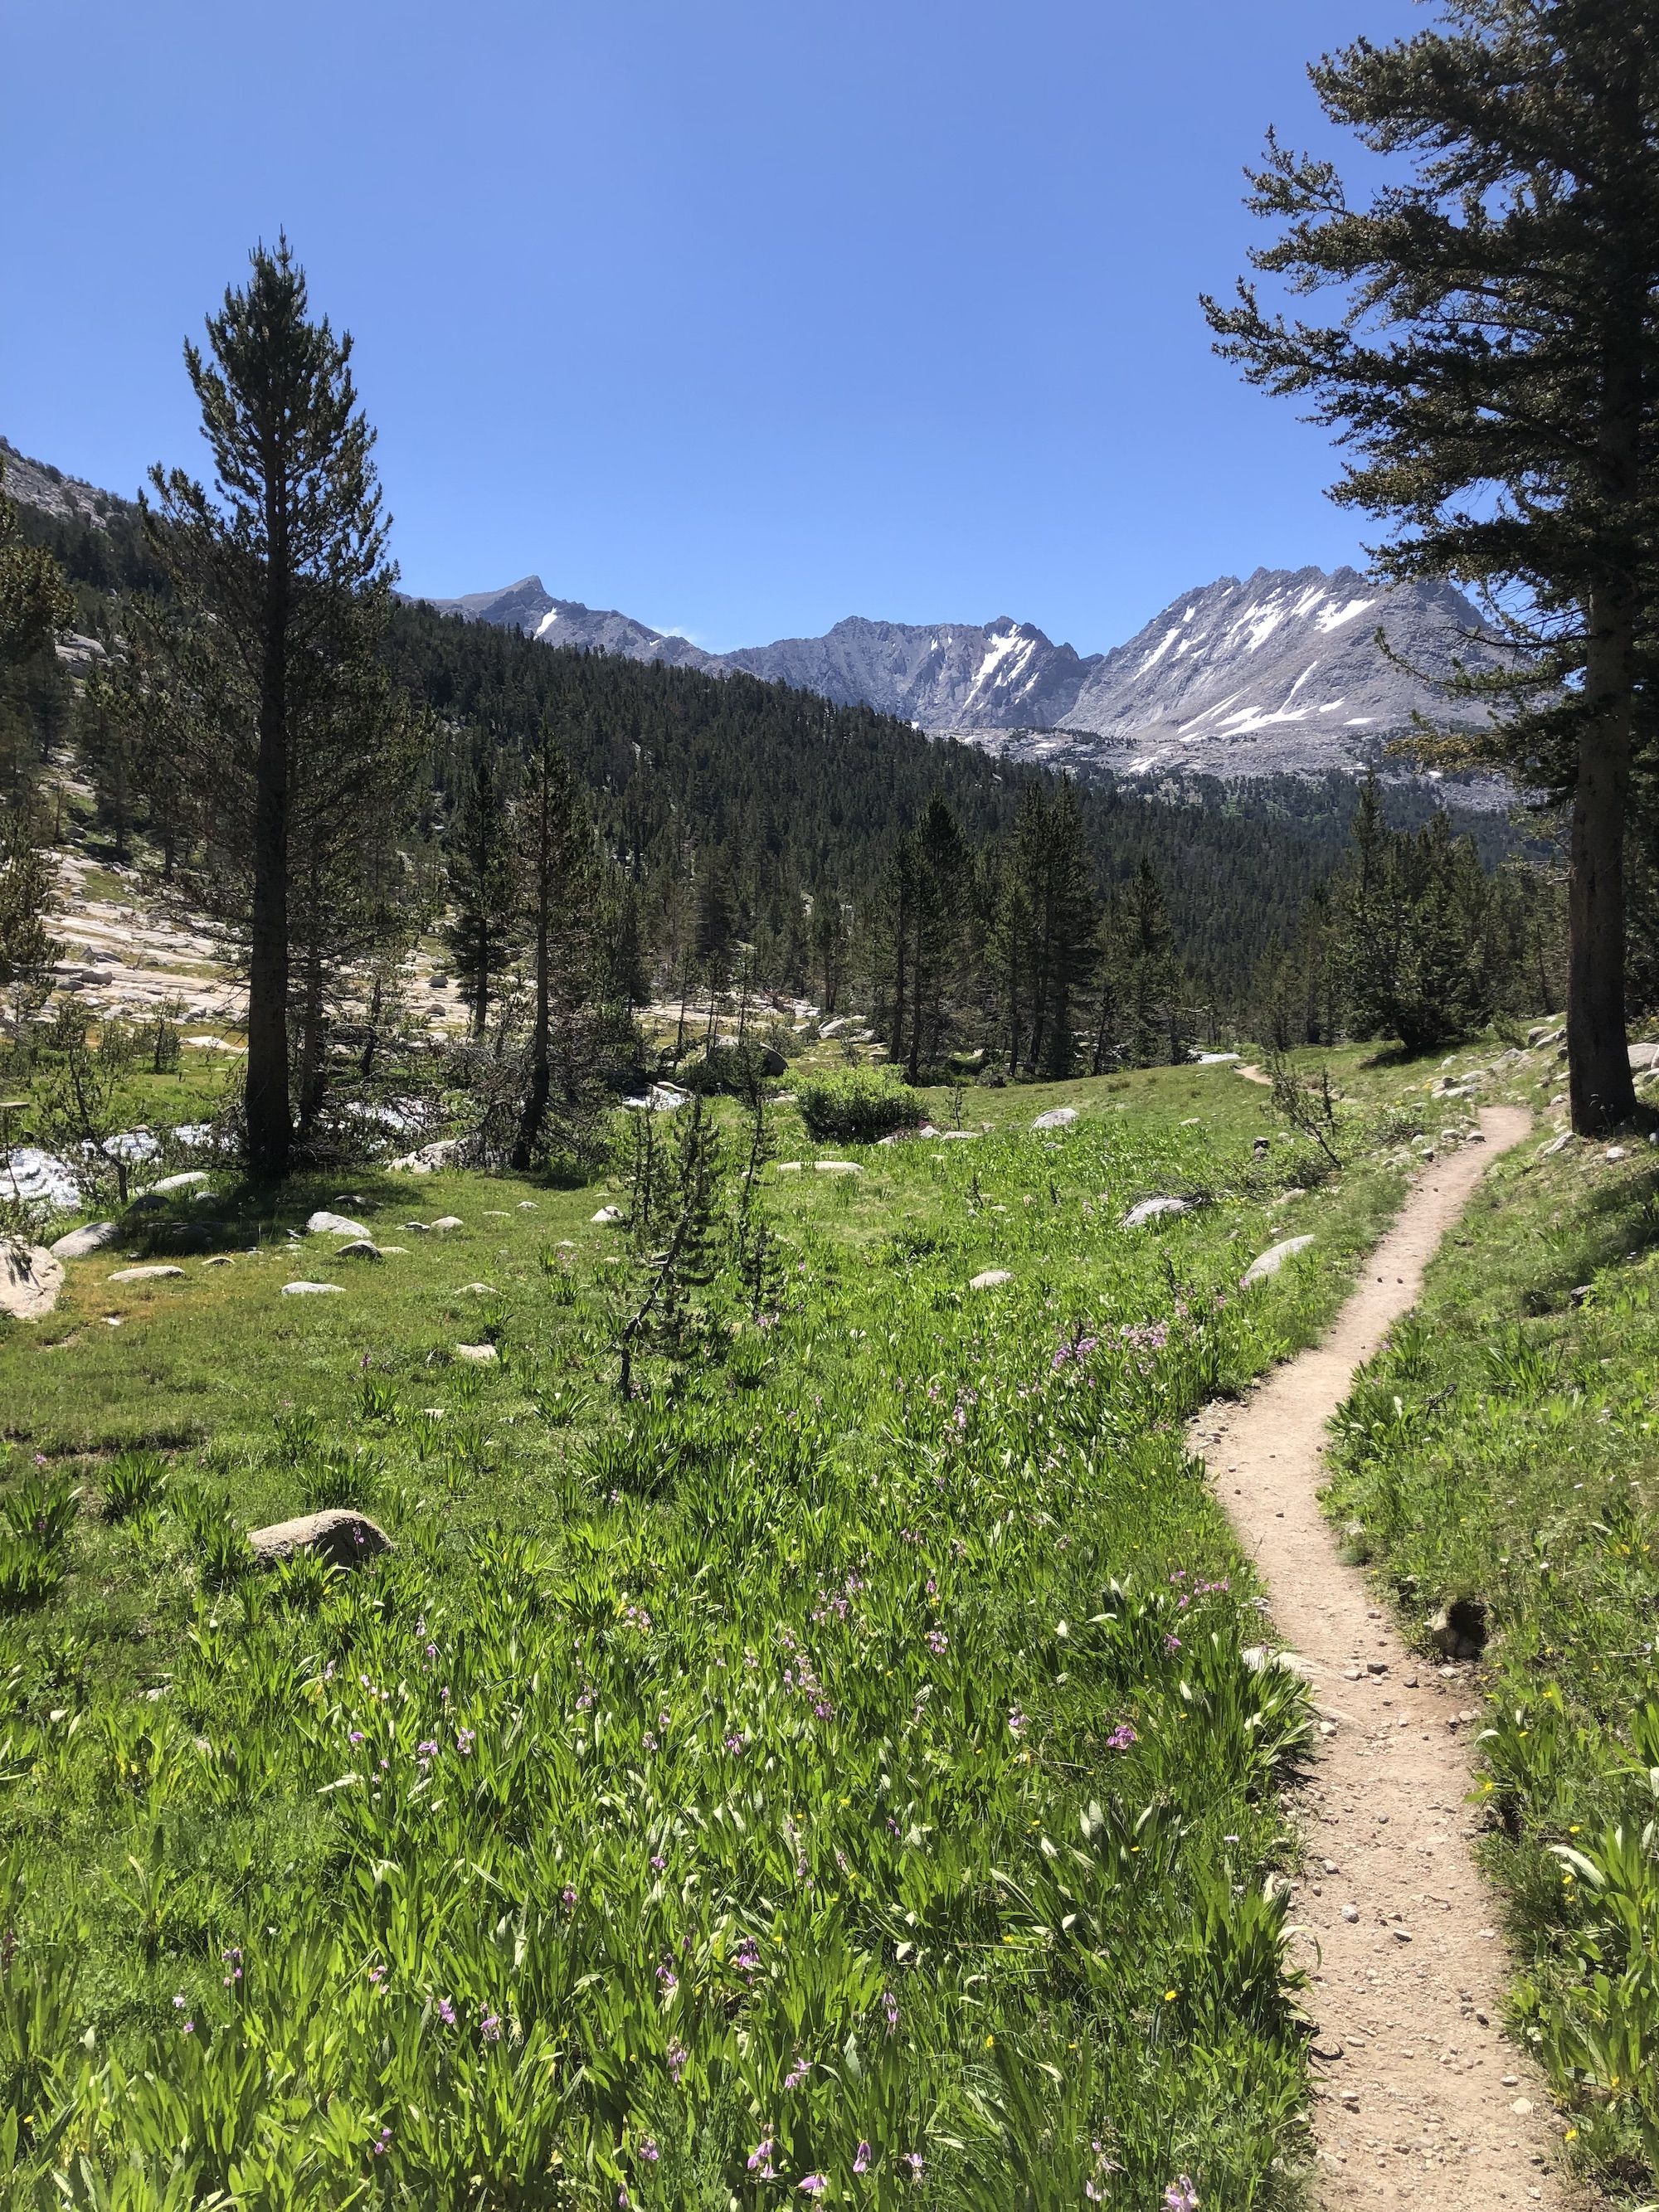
[133,239,401,1174]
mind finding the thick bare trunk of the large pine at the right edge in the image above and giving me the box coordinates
[1566,584,1637,1137]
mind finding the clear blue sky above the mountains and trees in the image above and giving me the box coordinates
[0,0,1423,650]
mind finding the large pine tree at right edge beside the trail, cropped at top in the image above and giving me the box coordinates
[1205,0,1659,1135]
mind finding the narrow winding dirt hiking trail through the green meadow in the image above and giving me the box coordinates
[1190,1106,1586,2212]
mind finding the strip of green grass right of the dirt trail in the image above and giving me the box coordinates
[1330,1055,1659,2188]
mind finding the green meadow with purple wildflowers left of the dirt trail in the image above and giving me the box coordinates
[0,1068,1400,2212]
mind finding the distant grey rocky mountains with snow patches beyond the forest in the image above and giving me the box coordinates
[431,568,1497,779]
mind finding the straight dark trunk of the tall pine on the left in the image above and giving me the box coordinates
[246,511,292,1177]
